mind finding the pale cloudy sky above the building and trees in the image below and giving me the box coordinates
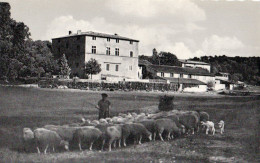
[4,0,260,59]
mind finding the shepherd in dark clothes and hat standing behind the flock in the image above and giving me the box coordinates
[96,93,111,119]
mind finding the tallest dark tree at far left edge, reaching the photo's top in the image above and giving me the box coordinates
[0,2,30,79]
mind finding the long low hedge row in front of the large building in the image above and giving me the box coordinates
[38,79,179,91]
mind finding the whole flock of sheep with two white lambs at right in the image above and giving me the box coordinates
[23,110,224,154]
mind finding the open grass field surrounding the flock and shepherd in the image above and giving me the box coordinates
[0,87,260,162]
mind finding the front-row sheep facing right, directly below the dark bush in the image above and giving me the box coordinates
[154,118,181,141]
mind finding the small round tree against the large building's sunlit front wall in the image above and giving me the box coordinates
[84,58,101,79]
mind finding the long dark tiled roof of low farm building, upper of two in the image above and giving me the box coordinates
[148,65,214,76]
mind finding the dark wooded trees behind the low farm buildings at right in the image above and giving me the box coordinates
[139,48,260,85]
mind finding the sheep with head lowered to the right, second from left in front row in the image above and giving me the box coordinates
[34,128,69,154]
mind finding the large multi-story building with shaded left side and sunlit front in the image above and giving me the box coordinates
[52,31,141,81]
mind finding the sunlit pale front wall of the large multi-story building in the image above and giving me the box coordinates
[85,36,141,80]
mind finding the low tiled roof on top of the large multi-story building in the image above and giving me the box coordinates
[53,31,139,42]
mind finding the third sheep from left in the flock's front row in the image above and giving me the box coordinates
[73,127,102,151]
